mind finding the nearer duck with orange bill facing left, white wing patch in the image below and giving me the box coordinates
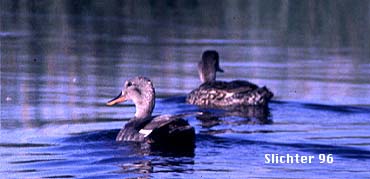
[106,76,195,144]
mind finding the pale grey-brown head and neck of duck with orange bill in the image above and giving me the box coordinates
[107,77,155,118]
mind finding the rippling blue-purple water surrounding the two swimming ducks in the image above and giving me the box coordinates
[0,0,370,178]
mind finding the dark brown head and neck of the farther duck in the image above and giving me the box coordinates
[198,50,224,83]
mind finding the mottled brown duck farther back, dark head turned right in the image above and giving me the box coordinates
[186,50,274,108]
